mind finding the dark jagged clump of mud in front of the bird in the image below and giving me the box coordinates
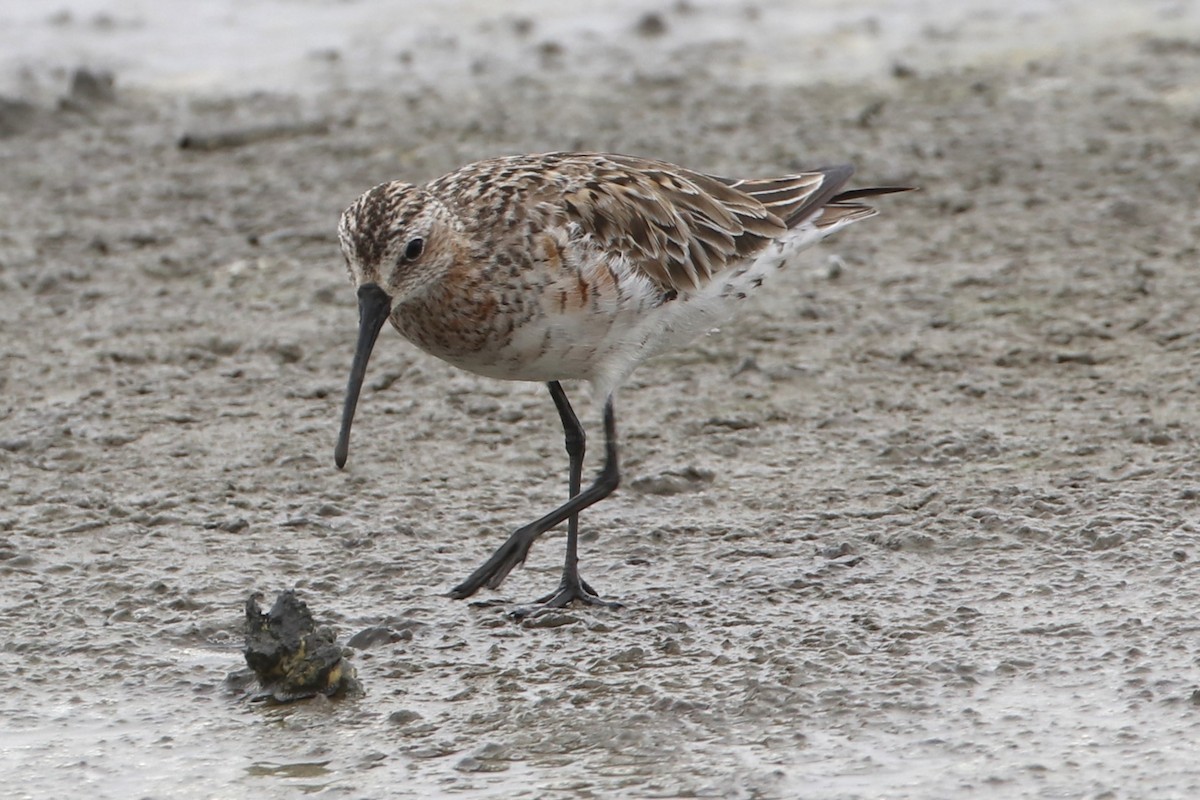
[242,589,364,703]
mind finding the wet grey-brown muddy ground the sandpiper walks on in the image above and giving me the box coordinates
[0,10,1200,799]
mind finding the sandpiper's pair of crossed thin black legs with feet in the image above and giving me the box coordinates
[450,381,620,604]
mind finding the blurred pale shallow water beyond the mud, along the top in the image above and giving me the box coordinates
[0,0,1200,96]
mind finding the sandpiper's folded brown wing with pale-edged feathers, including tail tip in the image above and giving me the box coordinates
[431,152,902,291]
